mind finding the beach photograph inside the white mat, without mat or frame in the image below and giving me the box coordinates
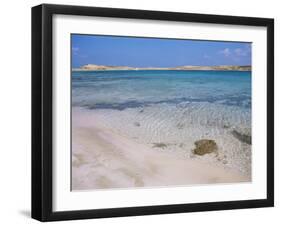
[70,33,252,191]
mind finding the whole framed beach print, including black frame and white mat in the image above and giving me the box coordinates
[32,4,274,221]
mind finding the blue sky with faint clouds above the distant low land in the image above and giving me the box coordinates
[71,34,251,68]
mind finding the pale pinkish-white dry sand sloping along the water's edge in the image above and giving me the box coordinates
[72,108,248,190]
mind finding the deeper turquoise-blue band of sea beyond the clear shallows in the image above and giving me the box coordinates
[72,71,251,110]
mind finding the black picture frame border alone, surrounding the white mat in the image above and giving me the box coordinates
[32,4,274,221]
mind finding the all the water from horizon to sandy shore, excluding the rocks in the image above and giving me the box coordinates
[72,71,251,177]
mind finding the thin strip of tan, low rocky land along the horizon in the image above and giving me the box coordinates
[72,64,252,71]
